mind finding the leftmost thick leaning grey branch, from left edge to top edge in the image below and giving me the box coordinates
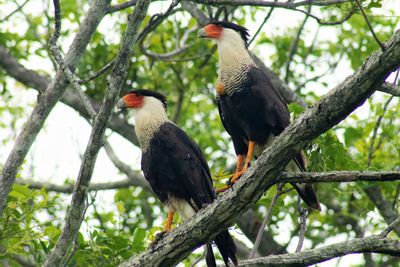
[0,0,109,219]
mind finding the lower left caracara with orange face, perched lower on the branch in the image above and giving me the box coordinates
[117,89,238,267]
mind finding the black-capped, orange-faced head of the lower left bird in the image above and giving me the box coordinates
[117,89,167,110]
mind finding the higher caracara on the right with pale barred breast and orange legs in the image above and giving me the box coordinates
[197,21,321,210]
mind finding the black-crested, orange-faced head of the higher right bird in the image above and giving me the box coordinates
[197,21,249,46]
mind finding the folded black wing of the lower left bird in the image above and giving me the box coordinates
[142,123,215,210]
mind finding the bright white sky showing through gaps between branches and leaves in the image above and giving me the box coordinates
[0,0,400,266]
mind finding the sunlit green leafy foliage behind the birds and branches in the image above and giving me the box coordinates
[0,0,400,266]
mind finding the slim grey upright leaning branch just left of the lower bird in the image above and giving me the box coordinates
[44,0,150,267]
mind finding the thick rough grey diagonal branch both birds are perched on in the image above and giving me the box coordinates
[122,28,400,266]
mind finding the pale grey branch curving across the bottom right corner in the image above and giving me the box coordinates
[239,236,400,266]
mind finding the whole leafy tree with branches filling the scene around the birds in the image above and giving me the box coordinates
[0,0,400,266]
